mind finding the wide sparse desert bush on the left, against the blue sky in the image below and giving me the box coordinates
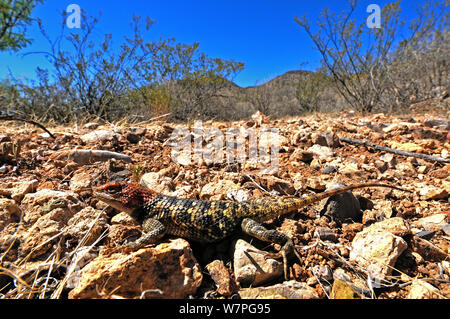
[2,12,243,122]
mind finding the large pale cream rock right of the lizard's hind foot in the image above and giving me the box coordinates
[350,217,409,280]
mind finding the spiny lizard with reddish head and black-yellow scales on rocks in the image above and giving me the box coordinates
[93,183,410,278]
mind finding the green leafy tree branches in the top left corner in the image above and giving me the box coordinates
[0,0,43,51]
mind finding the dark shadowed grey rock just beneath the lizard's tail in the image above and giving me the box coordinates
[320,188,363,223]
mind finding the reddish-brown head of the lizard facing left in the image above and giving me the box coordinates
[94,183,155,214]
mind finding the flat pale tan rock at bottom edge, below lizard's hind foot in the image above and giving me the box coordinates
[239,280,318,299]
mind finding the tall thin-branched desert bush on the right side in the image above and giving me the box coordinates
[295,0,449,112]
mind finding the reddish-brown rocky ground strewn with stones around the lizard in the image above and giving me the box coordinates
[0,113,450,299]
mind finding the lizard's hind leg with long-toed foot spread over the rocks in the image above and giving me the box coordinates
[241,218,301,280]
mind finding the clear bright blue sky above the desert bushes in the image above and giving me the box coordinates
[0,0,423,87]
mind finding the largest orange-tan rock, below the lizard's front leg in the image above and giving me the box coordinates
[69,239,202,299]
